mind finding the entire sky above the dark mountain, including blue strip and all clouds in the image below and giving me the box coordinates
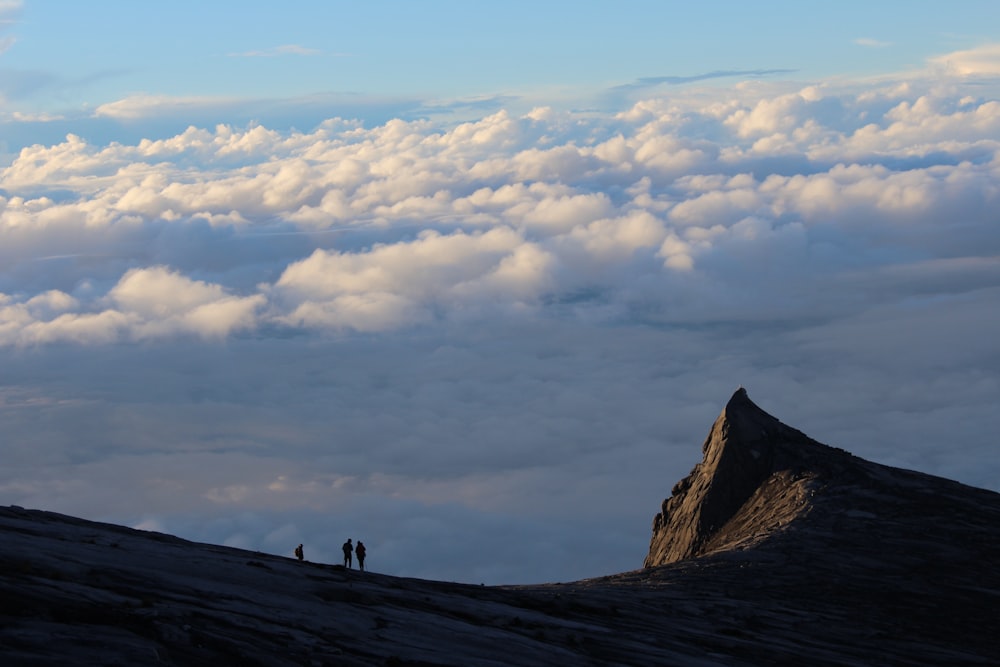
[0,0,1000,584]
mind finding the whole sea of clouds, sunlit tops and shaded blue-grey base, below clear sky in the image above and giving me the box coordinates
[0,48,1000,583]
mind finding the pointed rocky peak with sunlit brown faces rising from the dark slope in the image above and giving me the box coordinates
[644,387,856,567]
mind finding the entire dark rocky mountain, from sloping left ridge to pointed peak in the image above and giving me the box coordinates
[0,389,1000,667]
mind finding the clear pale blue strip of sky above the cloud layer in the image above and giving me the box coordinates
[0,0,1000,130]
